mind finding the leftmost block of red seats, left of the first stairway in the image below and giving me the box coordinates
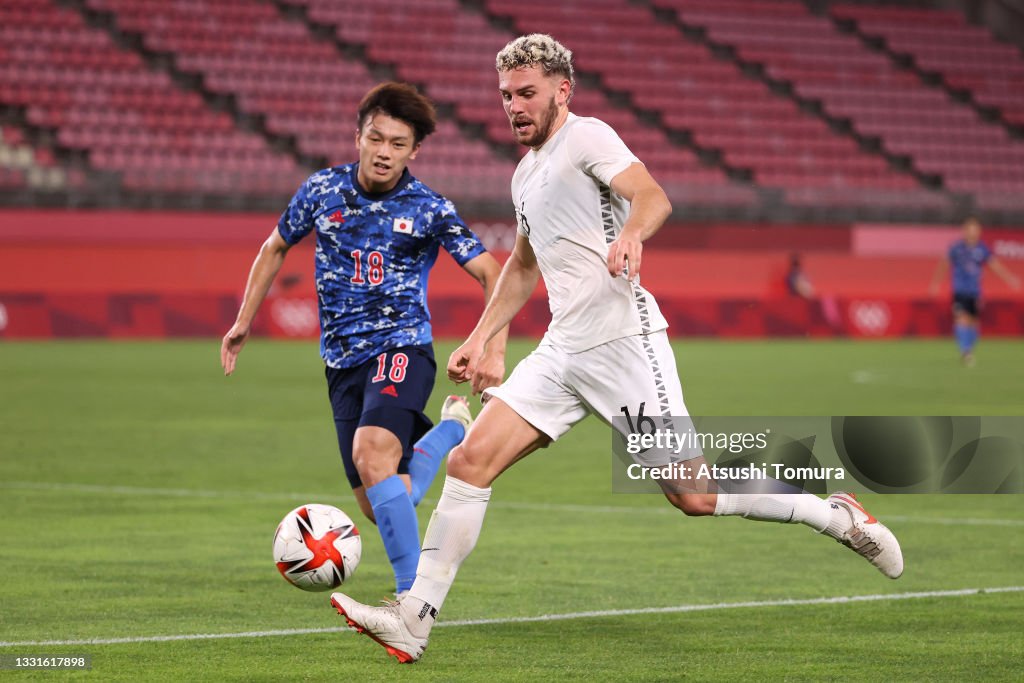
[0,0,298,201]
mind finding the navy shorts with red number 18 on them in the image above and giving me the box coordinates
[326,344,437,488]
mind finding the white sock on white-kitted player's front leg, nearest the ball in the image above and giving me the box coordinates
[401,476,490,638]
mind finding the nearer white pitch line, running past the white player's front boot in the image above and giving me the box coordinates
[0,586,1024,647]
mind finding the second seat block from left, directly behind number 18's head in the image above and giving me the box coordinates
[88,0,512,201]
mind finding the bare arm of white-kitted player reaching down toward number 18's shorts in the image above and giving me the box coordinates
[447,234,541,393]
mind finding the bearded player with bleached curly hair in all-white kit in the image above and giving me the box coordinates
[331,34,903,663]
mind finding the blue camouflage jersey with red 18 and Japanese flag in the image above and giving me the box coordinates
[278,163,485,368]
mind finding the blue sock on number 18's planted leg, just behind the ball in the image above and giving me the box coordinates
[367,474,420,593]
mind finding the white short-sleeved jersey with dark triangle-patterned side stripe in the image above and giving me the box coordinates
[512,114,669,353]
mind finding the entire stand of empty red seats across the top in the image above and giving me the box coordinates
[0,0,1024,221]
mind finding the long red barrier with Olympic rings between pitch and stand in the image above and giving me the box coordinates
[0,210,1024,339]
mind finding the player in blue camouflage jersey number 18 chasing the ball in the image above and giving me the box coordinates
[220,83,507,594]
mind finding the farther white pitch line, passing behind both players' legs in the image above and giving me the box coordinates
[0,481,1024,526]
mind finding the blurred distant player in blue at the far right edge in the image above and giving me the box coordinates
[931,216,1021,367]
